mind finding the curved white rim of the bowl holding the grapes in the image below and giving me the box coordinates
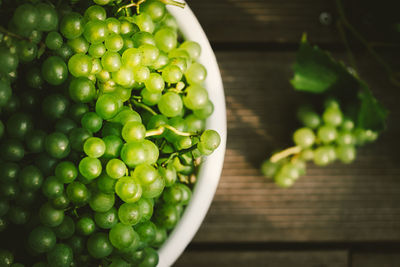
[158,4,227,267]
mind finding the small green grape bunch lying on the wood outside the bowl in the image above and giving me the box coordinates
[261,98,378,187]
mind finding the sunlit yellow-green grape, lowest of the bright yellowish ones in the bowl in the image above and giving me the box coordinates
[115,176,142,203]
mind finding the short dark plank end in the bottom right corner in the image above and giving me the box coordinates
[351,252,400,267]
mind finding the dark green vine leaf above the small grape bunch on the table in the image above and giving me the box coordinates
[290,36,388,132]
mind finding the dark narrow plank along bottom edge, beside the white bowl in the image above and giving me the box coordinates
[174,251,348,267]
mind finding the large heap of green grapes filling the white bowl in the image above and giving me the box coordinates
[0,0,220,267]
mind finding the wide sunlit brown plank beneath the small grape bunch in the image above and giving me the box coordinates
[190,51,400,242]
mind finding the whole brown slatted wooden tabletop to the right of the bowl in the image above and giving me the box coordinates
[175,0,400,267]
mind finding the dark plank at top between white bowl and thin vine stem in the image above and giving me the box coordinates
[189,0,340,43]
